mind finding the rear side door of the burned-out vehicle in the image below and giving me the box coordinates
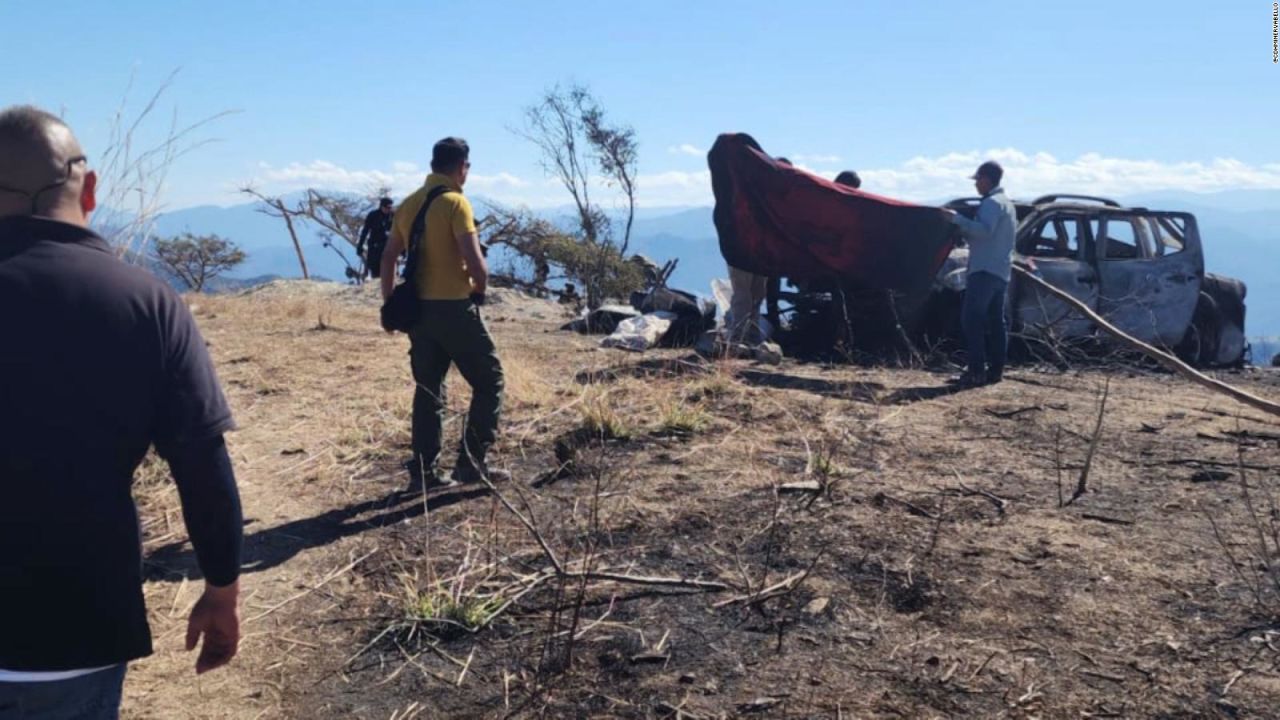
[1091,210,1204,347]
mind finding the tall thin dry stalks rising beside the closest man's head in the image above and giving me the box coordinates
[93,70,234,259]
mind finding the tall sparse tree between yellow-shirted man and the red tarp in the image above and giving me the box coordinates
[518,85,636,307]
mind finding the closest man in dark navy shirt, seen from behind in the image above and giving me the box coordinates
[0,106,242,719]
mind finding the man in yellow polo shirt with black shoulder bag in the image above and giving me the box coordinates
[381,137,503,488]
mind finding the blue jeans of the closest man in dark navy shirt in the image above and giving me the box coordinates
[0,662,127,720]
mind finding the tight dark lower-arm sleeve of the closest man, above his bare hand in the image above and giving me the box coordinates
[169,436,244,587]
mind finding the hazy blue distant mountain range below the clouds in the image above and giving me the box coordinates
[149,191,1280,337]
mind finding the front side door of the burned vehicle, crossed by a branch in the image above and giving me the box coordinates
[1009,210,1098,340]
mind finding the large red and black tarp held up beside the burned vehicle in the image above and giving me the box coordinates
[707,133,952,295]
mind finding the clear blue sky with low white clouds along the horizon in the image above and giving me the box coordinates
[0,0,1280,208]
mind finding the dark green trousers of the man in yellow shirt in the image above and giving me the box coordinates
[410,300,503,468]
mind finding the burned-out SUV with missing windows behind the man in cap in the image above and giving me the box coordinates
[934,195,1245,366]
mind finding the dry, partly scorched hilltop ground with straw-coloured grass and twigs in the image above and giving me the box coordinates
[125,283,1280,719]
